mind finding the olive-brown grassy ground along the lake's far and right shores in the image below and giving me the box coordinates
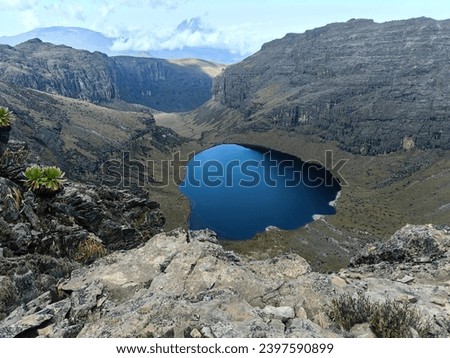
[157,110,450,270]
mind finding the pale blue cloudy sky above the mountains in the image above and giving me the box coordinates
[0,0,450,55]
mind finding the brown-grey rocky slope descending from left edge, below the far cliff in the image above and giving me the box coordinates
[0,82,183,181]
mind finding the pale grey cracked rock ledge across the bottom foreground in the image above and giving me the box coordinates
[0,226,450,337]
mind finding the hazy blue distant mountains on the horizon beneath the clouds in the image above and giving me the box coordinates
[0,26,243,64]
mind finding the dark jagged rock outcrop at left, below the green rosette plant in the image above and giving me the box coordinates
[0,178,164,261]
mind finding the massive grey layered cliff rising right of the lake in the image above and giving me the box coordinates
[213,18,450,155]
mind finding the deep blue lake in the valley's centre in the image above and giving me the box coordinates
[180,144,340,240]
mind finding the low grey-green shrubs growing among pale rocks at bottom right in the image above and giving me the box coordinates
[328,294,431,338]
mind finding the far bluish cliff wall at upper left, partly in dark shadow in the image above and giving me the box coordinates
[0,39,212,112]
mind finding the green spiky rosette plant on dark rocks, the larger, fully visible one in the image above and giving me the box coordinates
[24,165,64,195]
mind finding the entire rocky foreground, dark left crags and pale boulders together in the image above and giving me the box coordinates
[0,123,450,338]
